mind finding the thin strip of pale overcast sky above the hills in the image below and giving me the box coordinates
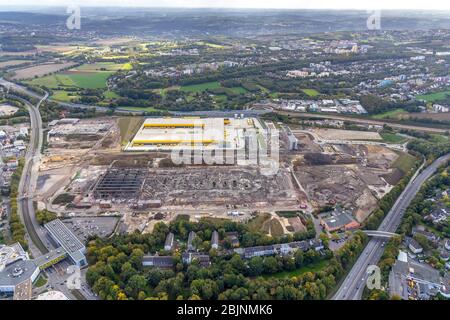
[0,0,450,10]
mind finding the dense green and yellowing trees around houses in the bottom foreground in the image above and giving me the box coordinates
[86,212,367,300]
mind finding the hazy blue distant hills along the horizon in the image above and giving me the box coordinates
[0,7,450,36]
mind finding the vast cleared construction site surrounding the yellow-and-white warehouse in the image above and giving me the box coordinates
[36,118,416,233]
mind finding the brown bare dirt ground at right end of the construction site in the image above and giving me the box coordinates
[294,145,398,222]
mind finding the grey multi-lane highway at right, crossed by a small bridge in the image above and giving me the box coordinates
[333,154,450,300]
